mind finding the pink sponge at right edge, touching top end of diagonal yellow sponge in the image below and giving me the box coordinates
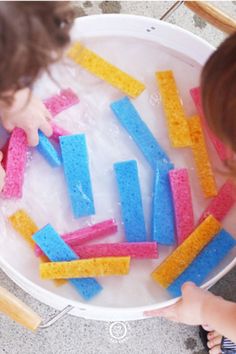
[199,181,236,223]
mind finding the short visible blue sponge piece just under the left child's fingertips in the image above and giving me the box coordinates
[37,131,61,167]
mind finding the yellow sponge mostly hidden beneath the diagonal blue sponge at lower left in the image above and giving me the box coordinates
[8,209,66,286]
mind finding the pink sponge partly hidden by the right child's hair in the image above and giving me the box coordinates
[190,87,230,161]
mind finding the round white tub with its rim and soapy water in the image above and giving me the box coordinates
[0,15,236,321]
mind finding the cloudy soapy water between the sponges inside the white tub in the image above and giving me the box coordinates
[0,37,235,307]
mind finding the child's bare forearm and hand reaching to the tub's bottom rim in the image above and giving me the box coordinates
[145,282,236,343]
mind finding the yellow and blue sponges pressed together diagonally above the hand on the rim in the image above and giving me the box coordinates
[152,215,236,295]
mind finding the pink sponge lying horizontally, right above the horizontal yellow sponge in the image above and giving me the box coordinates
[74,242,158,259]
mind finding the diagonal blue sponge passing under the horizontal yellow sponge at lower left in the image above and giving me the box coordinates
[32,224,102,300]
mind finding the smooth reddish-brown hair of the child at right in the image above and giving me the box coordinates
[201,33,236,177]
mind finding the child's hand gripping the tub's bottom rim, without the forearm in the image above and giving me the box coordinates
[144,282,214,325]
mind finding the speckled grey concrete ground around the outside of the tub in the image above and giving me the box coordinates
[0,1,236,354]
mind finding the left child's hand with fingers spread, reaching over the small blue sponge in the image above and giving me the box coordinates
[0,88,52,146]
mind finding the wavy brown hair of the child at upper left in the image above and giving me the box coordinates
[0,1,74,102]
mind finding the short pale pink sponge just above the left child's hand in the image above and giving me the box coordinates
[44,89,79,117]
